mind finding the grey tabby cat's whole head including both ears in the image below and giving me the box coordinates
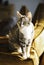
[17,11,32,27]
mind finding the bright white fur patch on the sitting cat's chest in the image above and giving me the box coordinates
[20,26,32,39]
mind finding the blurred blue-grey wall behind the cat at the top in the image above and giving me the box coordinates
[3,0,44,15]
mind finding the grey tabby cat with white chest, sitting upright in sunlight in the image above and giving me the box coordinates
[10,12,34,59]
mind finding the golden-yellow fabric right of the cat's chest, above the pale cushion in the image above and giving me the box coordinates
[34,19,44,39]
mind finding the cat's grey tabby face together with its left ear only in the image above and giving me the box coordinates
[17,12,31,27]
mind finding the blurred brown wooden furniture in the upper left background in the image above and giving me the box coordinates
[0,4,14,20]
